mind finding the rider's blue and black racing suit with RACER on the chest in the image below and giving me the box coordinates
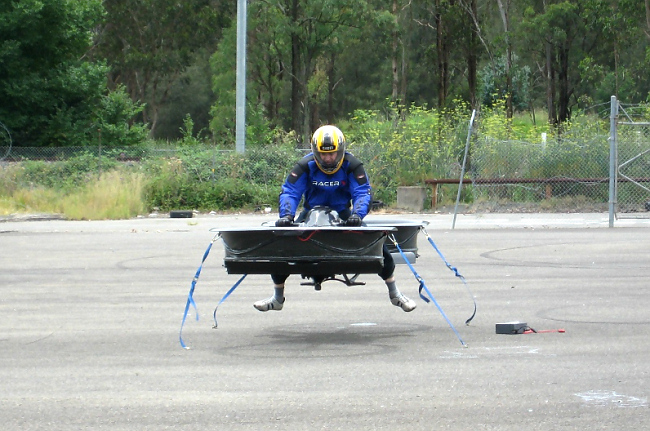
[271,152,395,284]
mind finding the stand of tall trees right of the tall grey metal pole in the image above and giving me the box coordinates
[202,0,650,139]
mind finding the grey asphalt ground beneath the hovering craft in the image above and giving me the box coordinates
[0,214,650,431]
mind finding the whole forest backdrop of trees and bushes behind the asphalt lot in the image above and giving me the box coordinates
[0,0,650,217]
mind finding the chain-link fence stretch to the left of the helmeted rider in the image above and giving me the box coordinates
[0,145,306,204]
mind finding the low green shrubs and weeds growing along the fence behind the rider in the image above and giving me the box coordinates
[0,101,628,218]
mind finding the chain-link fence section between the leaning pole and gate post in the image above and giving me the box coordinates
[394,109,609,212]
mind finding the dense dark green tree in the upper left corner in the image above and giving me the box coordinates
[0,0,107,146]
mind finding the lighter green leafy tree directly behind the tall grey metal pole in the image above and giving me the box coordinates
[212,0,369,141]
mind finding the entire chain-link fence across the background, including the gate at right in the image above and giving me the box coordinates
[0,103,650,215]
